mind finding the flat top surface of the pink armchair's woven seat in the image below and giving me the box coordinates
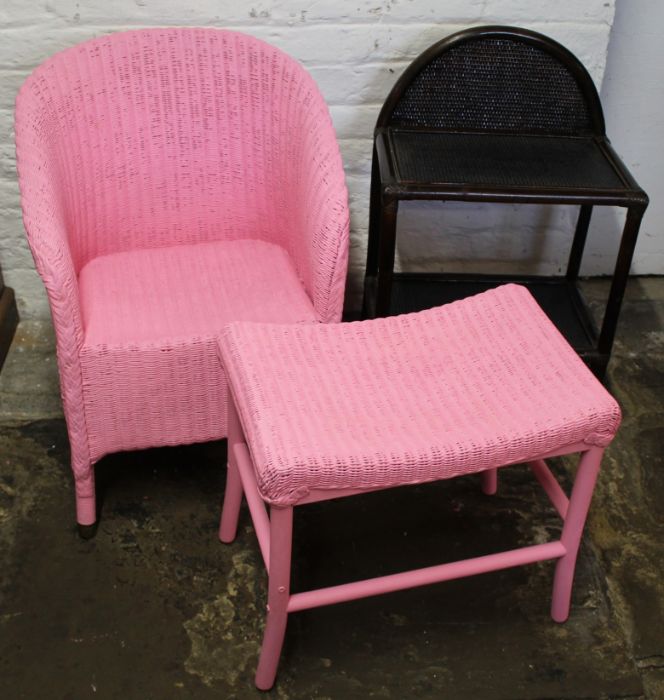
[79,240,316,346]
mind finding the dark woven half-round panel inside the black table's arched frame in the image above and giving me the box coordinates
[390,36,594,135]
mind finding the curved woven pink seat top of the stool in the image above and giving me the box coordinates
[220,285,620,505]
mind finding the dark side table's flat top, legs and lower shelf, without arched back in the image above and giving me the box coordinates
[363,127,648,377]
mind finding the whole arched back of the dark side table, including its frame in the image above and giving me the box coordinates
[376,26,605,136]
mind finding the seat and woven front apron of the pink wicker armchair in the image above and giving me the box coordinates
[78,240,317,461]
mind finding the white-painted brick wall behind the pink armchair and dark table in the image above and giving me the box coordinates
[0,0,615,317]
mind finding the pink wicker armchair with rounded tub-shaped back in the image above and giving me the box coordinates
[16,29,348,532]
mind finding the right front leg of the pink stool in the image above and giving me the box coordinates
[551,447,604,622]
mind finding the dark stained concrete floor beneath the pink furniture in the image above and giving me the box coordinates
[0,278,664,700]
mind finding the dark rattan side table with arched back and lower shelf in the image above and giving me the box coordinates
[363,27,648,377]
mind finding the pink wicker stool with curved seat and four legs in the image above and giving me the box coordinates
[219,285,620,689]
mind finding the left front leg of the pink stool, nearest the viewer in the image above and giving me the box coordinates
[256,506,293,690]
